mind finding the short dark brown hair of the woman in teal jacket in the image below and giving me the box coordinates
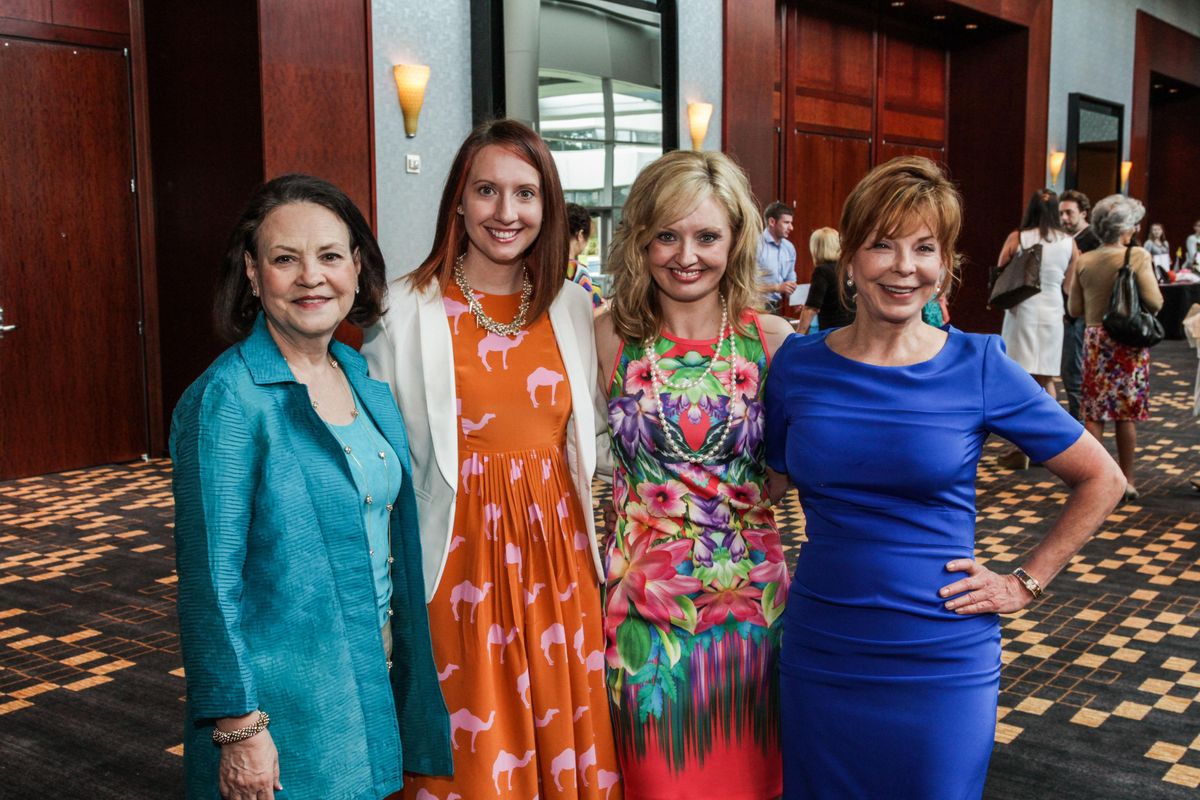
[212,173,388,342]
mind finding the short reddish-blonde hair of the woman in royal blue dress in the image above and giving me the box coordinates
[838,156,962,302]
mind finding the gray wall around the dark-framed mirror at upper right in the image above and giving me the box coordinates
[1046,0,1200,182]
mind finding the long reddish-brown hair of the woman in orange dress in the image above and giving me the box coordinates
[406,119,569,321]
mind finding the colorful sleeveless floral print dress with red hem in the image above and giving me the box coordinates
[605,317,788,800]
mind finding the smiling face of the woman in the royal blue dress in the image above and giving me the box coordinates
[848,222,944,324]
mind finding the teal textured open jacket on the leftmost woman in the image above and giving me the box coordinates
[170,315,452,800]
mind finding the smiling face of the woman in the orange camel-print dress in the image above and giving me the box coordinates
[460,145,542,265]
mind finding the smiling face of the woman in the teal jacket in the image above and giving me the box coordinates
[246,203,359,342]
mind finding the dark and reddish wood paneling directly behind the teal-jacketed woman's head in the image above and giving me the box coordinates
[145,0,376,438]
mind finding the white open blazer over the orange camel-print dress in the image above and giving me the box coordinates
[362,278,608,602]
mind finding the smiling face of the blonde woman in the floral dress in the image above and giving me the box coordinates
[646,196,733,302]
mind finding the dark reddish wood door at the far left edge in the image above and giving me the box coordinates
[0,40,146,480]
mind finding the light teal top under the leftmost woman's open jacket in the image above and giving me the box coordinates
[325,390,404,627]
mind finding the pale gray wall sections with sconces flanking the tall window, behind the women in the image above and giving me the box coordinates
[371,0,724,277]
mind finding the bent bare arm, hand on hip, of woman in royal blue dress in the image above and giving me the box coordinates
[940,433,1126,614]
